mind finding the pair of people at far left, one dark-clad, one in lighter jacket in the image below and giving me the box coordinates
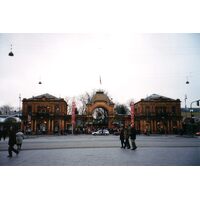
[8,126,24,158]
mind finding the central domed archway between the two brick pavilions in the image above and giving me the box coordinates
[86,91,115,128]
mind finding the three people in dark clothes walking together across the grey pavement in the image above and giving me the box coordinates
[120,125,137,150]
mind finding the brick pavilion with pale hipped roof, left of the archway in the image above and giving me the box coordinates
[22,94,68,134]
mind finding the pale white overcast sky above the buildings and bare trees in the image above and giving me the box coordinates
[0,33,200,107]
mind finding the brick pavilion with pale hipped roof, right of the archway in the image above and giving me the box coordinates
[135,94,182,133]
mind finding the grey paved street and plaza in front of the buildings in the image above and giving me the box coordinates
[0,135,200,166]
